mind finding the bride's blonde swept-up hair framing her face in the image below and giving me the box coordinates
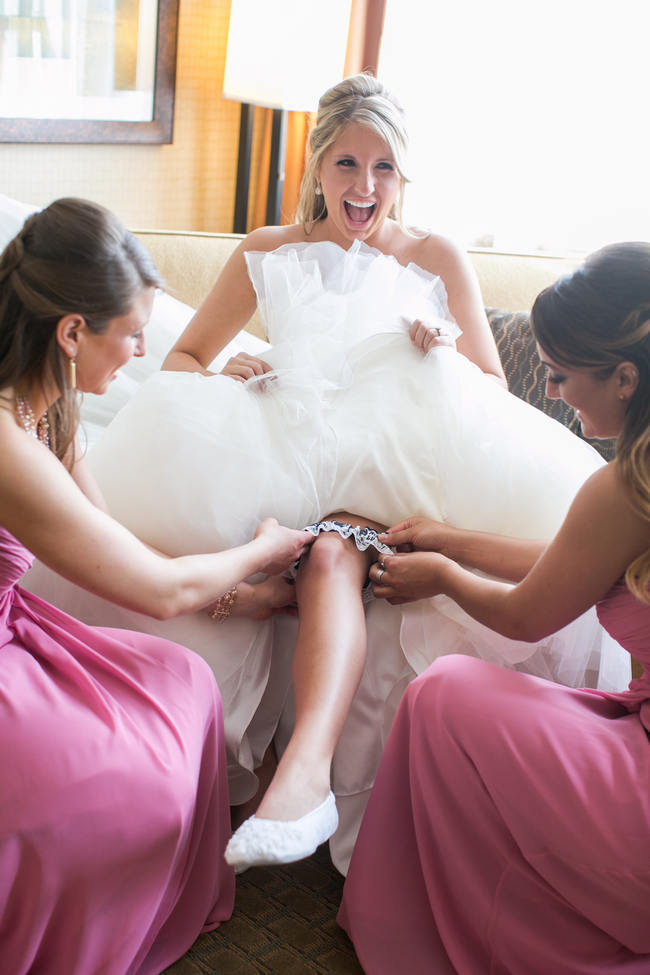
[296,74,408,232]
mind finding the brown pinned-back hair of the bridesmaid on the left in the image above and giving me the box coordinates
[0,197,162,462]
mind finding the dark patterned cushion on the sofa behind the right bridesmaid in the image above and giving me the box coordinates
[485,308,614,460]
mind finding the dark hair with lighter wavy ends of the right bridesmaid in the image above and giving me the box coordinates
[531,242,650,602]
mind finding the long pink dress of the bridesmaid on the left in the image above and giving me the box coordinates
[0,528,234,975]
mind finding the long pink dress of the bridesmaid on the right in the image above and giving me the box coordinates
[339,583,650,975]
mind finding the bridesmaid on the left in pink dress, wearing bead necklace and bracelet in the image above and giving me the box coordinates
[0,199,309,975]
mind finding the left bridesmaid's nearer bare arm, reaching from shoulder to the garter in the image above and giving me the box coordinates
[0,415,313,619]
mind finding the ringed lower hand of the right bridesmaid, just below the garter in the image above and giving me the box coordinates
[369,552,453,606]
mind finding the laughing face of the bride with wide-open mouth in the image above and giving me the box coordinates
[319,123,402,248]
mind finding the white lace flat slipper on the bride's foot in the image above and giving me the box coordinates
[224,792,339,873]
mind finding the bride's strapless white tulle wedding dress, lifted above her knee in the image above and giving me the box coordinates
[28,242,629,872]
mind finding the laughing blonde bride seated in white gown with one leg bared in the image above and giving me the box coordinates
[26,75,627,872]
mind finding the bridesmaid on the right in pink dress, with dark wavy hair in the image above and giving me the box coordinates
[339,243,650,975]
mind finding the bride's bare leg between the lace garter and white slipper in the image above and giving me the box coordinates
[255,513,383,820]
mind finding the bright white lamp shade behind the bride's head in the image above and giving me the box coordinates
[223,0,351,112]
